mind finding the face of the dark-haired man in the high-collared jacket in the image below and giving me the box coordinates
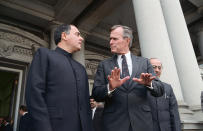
[64,25,84,53]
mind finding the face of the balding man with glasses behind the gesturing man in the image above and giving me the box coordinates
[150,59,162,77]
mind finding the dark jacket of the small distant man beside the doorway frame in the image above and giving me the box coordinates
[19,113,30,131]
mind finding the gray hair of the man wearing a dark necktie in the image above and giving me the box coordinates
[110,25,133,47]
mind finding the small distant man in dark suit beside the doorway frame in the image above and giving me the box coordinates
[19,105,30,131]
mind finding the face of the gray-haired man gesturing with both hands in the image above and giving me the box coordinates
[110,27,130,54]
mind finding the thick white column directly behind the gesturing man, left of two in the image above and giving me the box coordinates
[133,0,184,103]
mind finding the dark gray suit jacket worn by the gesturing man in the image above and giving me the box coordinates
[92,55,163,131]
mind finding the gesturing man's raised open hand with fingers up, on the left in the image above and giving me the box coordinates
[108,67,130,91]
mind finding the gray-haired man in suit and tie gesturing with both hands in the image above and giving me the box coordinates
[92,25,163,131]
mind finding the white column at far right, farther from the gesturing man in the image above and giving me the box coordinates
[160,0,203,108]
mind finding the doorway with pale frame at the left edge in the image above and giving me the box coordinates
[0,66,23,131]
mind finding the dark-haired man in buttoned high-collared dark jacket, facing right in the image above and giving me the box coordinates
[26,25,93,131]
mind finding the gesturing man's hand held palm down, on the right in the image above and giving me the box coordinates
[133,73,156,86]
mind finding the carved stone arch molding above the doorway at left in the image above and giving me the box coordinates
[0,24,44,59]
